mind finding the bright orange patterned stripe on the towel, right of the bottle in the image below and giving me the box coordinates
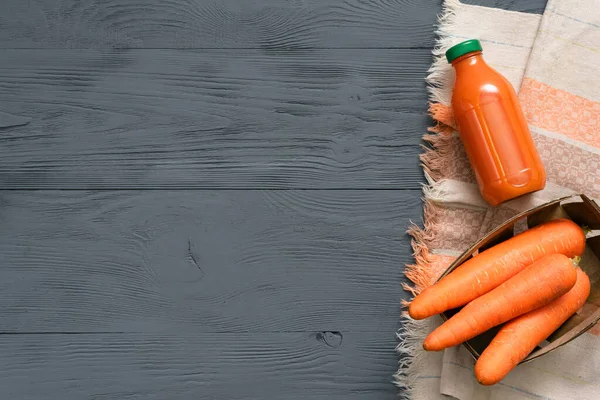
[519,78,600,148]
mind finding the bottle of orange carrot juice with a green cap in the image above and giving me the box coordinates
[446,40,546,206]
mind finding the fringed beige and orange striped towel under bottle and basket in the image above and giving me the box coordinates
[396,0,600,400]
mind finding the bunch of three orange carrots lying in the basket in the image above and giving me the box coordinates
[409,219,590,385]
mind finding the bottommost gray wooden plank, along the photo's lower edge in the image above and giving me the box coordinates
[0,331,397,400]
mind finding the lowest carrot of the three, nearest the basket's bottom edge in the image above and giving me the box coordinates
[475,269,590,385]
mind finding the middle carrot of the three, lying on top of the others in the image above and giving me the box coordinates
[423,254,577,351]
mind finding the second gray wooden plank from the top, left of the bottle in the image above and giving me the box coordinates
[0,49,431,189]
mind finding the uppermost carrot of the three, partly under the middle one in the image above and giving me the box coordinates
[408,219,585,319]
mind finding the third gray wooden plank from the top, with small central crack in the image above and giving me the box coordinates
[0,190,421,335]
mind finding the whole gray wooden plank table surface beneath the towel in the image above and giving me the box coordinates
[0,0,544,400]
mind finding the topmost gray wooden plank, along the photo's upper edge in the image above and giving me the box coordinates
[0,0,545,52]
